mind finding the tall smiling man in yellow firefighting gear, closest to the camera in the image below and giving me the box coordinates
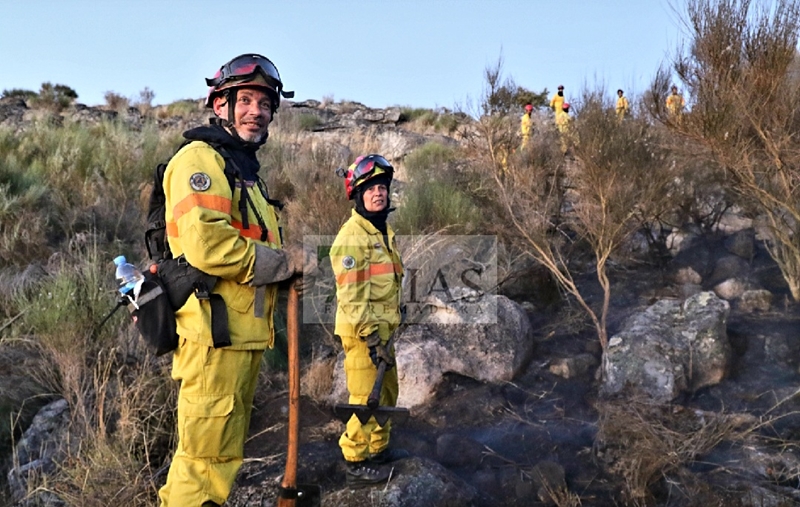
[158,53,313,507]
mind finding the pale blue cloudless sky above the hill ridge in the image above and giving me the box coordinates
[0,0,682,108]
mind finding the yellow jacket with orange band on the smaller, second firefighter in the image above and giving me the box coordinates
[330,210,404,342]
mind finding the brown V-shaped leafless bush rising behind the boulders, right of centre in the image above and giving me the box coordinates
[482,81,672,358]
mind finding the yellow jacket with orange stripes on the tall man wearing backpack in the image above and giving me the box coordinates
[164,141,281,350]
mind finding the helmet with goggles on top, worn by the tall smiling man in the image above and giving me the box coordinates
[206,53,294,112]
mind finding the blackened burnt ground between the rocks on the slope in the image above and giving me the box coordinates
[239,240,800,506]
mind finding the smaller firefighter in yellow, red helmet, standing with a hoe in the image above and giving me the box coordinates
[330,154,408,487]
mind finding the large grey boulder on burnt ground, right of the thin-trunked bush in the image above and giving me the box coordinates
[601,292,732,403]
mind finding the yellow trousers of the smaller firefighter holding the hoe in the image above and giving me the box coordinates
[339,336,398,461]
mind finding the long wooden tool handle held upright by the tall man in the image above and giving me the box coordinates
[278,278,300,507]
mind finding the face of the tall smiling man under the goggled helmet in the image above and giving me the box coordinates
[214,88,272,143]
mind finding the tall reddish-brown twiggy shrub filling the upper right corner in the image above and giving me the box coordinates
[649,0,800,300]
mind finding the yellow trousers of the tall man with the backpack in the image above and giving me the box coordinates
[158,339,264,507]
